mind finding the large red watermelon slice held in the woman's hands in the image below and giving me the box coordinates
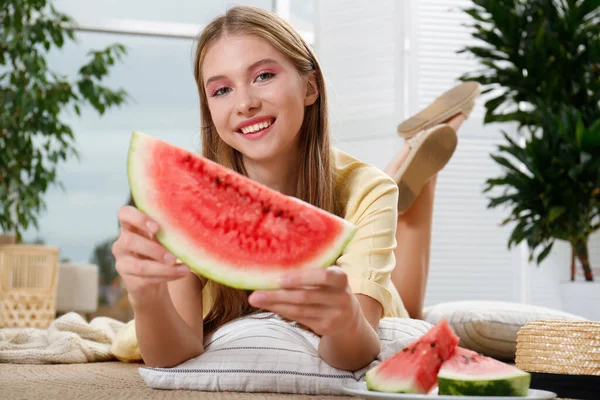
[123,131,356,290]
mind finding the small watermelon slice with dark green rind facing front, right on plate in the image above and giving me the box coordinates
[438,347,531,396]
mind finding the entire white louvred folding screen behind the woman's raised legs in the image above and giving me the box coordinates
[314,0,600,308]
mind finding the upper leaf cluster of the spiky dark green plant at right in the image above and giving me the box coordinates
[461,0,600,126]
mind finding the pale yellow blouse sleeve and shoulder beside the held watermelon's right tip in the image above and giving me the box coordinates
[334,149,408,317]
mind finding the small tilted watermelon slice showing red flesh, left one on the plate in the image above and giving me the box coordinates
[365,319,459,394]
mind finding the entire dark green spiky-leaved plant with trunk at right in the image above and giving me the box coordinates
[461,0,600,319]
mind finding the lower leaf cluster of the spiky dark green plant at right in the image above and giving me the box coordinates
[485,108,600,263]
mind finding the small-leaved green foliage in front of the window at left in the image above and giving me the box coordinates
[0,0,127,241]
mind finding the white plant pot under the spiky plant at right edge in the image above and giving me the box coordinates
[560,281,600,321]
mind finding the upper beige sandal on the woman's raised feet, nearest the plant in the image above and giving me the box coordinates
[397,81,481,139]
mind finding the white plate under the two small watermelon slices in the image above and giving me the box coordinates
[344,382,556,400]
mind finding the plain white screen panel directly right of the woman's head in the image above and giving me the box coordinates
[314,0,404,169]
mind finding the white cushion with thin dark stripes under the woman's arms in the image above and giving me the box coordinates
[139,313,432,395]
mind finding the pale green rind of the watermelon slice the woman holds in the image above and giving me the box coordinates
[127,131,357,290]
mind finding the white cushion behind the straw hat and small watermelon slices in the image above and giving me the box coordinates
[423,301,585,361]
